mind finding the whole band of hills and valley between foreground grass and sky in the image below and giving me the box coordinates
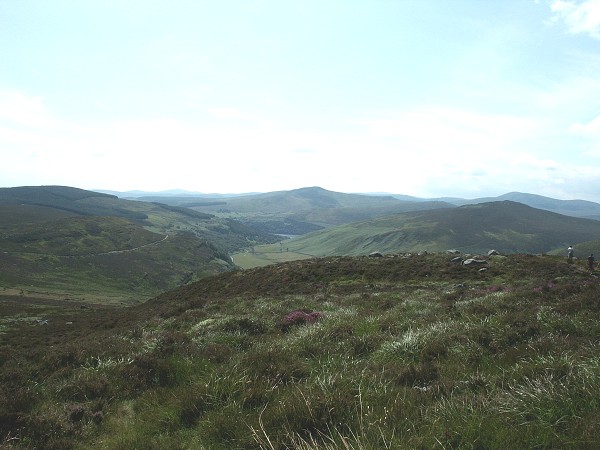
[0,186,600,297]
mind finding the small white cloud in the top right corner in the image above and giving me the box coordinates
[550,0,600,39]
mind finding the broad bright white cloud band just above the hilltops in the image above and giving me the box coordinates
[0,90,600,203]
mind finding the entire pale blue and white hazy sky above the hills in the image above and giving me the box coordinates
[0,0,600,202]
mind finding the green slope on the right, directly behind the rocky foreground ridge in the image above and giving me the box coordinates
[284,201,600,256]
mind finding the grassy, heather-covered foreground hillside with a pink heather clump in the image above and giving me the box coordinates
[0,255,600,449]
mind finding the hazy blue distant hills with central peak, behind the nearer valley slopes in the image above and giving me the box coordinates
[120,187,600,241]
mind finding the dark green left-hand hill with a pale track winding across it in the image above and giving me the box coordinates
[0,186,275,303]
